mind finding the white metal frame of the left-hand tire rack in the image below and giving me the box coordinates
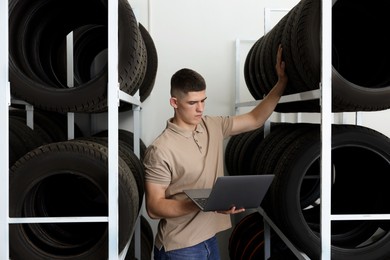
[0,0,141,260]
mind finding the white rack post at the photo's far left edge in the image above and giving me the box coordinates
[0,0,11,259]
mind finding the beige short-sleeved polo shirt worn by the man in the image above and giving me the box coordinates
[144,116,233,251]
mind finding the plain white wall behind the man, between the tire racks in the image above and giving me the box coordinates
[130,0,298,144]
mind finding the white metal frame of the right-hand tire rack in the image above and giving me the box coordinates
[235,0,334,260]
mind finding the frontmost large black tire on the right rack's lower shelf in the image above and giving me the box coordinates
[271,125,390,260]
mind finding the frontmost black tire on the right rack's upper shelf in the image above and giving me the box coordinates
[332,0,390,111]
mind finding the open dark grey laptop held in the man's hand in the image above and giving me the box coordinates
[184,174,275,211]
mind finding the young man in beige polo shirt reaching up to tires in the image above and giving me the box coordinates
[144,46,287,260]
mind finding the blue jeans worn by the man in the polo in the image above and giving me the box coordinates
[154,236,220,260]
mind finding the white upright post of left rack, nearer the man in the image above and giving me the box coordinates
[107,0,119,260]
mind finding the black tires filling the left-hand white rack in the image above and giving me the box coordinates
[9,0,158,260]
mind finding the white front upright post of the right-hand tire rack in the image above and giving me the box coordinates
[320,0,332,260]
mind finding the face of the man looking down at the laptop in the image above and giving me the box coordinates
[171,90,207,129]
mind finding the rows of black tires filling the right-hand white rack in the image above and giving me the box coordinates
[225,0,390,260]
